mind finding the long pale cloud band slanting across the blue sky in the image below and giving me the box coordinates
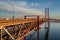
[0,2,42,15]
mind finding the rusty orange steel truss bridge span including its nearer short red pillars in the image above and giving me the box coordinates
[0,16,47,40]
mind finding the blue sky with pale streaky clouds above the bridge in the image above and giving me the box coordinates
[0,0,60,18]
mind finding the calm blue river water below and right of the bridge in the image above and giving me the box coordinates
[26,23,60,40]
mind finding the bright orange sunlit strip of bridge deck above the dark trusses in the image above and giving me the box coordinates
[0,19,36,29]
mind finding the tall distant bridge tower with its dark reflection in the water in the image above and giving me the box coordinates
[44,8,50,40]
